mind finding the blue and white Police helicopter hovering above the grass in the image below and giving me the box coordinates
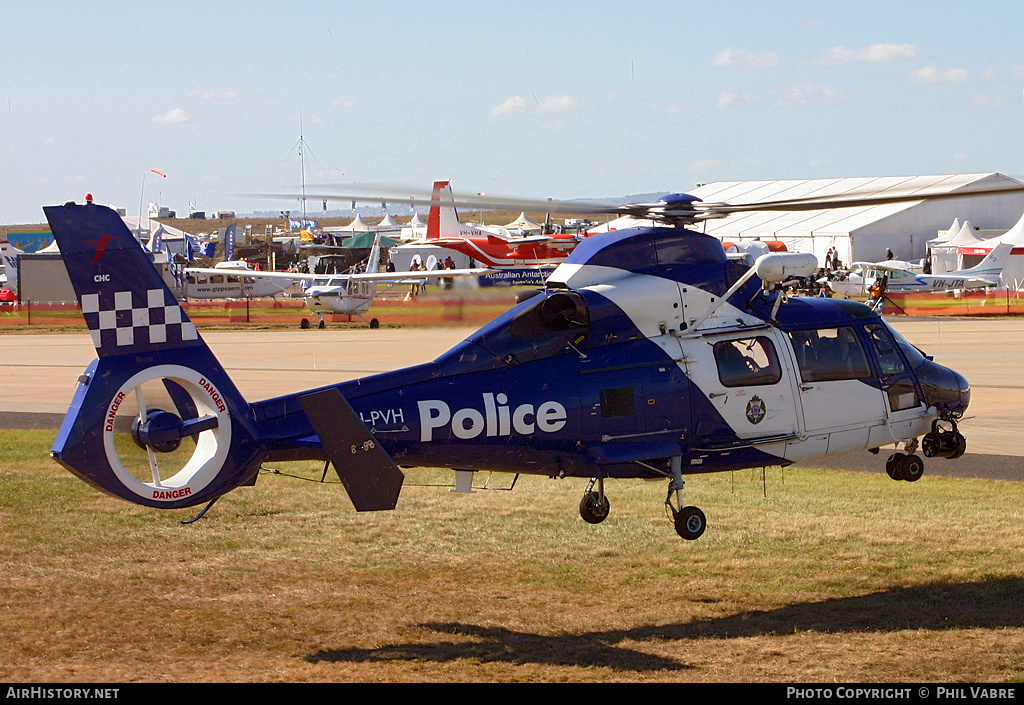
[44,184,999,540]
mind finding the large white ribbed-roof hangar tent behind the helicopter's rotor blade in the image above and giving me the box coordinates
[689,173,1024,263]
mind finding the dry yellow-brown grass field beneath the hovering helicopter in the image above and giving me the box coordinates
[0,430,1024,682]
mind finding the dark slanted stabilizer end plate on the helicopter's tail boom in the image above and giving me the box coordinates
[299,388,406,511]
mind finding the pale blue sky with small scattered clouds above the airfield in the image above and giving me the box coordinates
[0,0,1024,224]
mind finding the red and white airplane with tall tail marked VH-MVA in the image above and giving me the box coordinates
[426,181,585,269]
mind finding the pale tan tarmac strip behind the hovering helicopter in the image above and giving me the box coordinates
[0,317,1024,481]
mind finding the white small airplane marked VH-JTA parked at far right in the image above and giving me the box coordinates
[827,243,1014,296]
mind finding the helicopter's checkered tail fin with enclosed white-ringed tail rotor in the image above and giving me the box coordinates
[43,203,262,508]
